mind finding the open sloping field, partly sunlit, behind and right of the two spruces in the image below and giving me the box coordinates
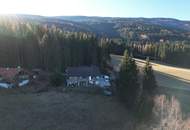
[111,55,190,115]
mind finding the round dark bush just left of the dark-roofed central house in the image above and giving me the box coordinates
[50,72,65,87]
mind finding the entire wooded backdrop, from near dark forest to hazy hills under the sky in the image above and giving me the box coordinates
[0,15,190,70]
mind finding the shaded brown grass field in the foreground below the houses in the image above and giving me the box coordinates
[0,90,132,130]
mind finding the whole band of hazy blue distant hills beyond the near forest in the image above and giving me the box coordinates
[1,15,190,42]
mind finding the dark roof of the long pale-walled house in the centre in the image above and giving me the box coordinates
[66,66,100,77]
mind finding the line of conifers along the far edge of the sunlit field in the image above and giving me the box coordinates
[109,41,190,67]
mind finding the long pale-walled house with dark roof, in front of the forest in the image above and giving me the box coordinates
[66,66,111,88]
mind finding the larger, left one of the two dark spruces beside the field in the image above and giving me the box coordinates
[118,50,139,108]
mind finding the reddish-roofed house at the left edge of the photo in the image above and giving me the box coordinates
[0,68,30,88]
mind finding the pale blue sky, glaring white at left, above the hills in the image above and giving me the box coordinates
[0,0,190,20]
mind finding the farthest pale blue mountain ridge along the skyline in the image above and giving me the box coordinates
[56,16,190,31]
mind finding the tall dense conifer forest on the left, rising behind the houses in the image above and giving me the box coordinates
[0,19,109,71]
